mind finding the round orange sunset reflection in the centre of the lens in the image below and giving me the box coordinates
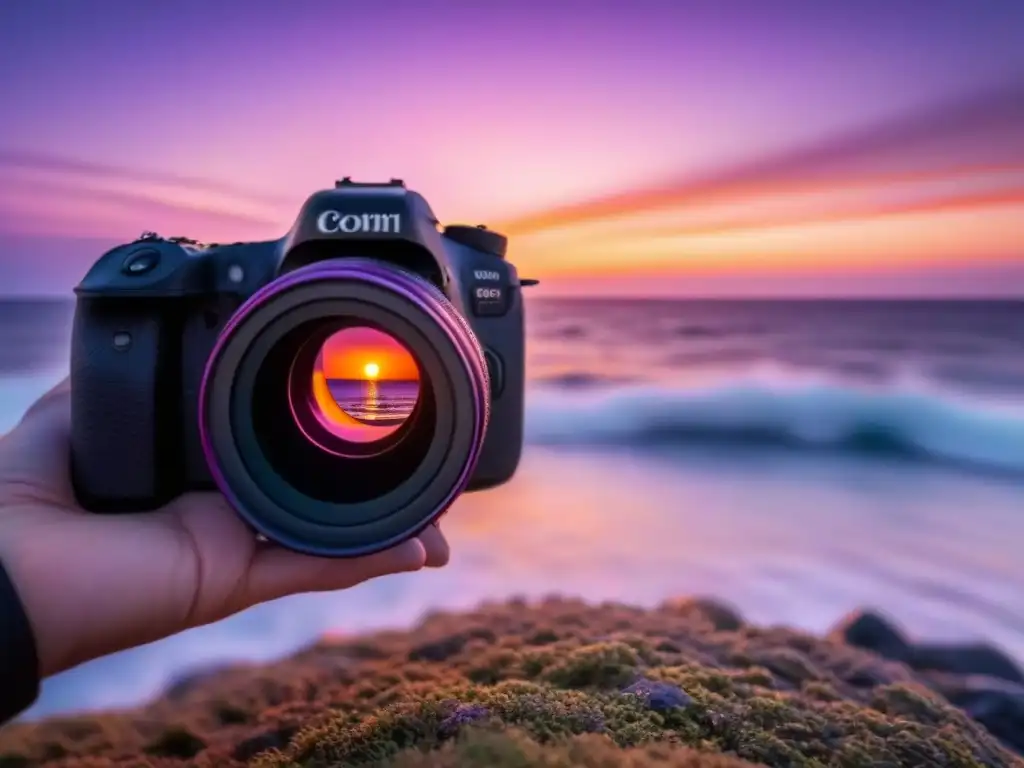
[312,328,420,442]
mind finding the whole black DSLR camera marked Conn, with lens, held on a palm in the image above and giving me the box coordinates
[71,178,537,557]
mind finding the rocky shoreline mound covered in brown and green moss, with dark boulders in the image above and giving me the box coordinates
[0,598,1024,768]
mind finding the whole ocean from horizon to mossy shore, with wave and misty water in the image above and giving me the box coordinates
[0,299,1024,717]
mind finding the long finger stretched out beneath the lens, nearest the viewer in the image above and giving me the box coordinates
[244,539,427,605]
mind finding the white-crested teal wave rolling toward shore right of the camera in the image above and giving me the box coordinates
[526,379,1024,477]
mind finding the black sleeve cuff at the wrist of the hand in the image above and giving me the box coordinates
[0,563,39,724]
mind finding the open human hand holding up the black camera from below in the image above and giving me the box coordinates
[0,380,449,677]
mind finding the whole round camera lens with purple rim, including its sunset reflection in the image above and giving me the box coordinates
[200,258,490,556]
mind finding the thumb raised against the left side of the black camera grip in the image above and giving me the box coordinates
[0,380,71,501]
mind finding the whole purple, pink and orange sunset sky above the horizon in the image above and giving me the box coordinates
[0,0,1024,296]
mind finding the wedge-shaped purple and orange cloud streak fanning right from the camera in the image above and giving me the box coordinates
[489,83,1024,288]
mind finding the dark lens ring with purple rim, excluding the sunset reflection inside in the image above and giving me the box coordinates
[199,258,489,556]
